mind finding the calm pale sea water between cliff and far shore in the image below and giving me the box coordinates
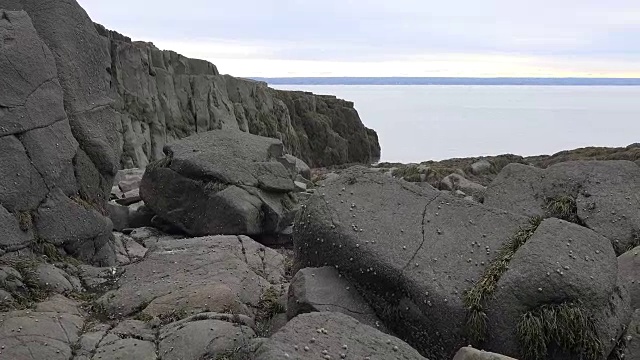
[273,85,640,162]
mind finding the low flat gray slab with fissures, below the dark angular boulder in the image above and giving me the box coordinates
[98,234,284,317]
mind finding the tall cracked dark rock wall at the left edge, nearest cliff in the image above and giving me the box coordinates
[0,7,119,264]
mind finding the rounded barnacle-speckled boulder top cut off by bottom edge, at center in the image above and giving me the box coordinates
[253,312,425,360]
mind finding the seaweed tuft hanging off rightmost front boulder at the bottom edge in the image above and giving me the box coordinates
[516,303,604,360]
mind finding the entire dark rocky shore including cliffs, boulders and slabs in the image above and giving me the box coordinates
[0,0,640,360]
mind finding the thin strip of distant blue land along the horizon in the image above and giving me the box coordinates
[248,77,640,86]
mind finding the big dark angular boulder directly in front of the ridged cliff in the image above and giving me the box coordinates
[140,130,295,236]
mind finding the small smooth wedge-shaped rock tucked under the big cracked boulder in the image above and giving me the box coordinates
[287,267,386,331]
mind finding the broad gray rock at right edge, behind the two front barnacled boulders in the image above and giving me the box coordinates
[485,160,640,254]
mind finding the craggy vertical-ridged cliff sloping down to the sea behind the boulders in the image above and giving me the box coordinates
[96,24,380,168]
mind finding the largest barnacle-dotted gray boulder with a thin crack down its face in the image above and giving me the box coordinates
[294,167,527,359]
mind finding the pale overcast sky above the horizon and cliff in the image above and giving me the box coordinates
[79,0,640,77]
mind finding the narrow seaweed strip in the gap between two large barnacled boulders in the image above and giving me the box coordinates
[463,217,542,344]
